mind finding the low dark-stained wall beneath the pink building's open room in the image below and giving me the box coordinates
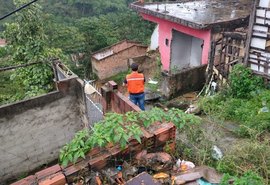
[161,65,206,99]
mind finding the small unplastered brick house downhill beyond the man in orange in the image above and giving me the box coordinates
[91,40,147,80]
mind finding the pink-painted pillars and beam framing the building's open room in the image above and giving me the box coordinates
[141,13,211,71]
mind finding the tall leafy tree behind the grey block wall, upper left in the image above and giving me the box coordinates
[4,0,61,97]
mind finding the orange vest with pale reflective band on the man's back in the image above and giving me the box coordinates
[126,71,145,94]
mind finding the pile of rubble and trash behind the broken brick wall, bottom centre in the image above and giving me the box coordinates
[89,150,222,185]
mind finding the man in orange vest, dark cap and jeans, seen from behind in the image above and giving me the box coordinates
[124,63,145,110]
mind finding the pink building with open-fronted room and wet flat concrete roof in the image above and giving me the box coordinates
[130,0,253,71]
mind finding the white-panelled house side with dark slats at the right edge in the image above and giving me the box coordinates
[245,0,270,80]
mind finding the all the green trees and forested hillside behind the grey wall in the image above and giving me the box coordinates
[0,0,154,104]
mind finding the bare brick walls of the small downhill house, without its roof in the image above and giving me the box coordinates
[92,45,146,80]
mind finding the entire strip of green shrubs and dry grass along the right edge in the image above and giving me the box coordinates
[199,65,270,184]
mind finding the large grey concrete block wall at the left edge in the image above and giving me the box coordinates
[0,79,86,184]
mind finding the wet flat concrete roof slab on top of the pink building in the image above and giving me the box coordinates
[130,0,254,29]
